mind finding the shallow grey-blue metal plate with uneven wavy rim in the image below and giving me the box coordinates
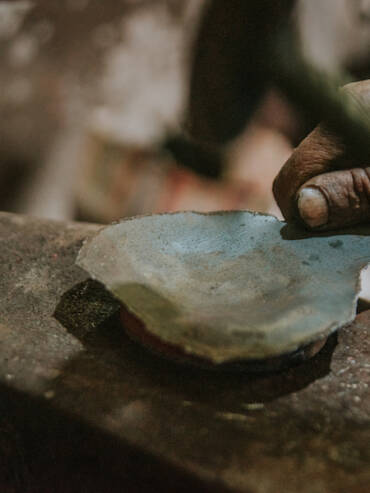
[77,211,370,364]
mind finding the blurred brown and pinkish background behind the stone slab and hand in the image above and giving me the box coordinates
[0,0,370,223]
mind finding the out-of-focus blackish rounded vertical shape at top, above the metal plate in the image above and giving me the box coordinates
[189,0,295,144]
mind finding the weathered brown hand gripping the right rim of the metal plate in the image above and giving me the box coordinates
[273,80,370,231]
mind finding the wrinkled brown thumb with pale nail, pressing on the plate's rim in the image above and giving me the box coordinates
[296,168,370,231]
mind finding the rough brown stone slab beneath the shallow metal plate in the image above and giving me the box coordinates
[0,209,370,493]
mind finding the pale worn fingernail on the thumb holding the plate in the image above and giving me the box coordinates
[297,187,329,228]
